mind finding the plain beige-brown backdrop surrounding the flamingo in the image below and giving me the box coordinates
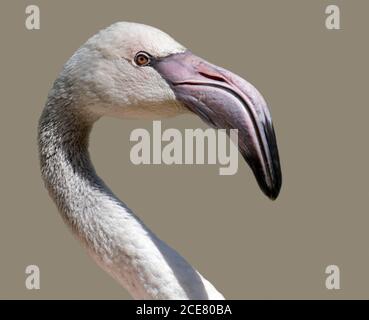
[0,0,369,299]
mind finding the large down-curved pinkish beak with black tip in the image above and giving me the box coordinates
[152,51,282,200]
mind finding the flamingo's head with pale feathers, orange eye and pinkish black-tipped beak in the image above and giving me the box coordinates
[61,22,282,199]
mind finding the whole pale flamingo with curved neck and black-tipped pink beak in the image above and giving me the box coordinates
[38,22,282,299]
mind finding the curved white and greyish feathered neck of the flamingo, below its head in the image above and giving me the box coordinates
[38,95,222,299]
